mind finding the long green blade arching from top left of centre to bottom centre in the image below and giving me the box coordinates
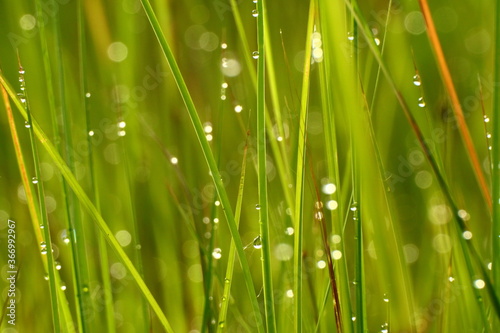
[137,0,263,332]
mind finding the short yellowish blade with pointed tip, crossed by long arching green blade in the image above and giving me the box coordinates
[217,132,248,333]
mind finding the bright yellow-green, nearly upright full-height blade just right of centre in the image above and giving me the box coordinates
[293,0,315,332]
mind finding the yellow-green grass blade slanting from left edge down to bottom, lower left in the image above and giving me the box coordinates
[0,73,173,333]
